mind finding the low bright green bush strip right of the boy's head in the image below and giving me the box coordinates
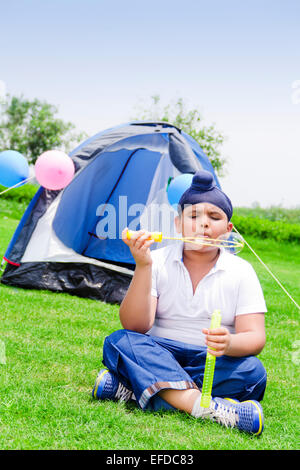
[232,215,300,243]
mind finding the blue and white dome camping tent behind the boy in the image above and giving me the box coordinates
[1,122,220,303]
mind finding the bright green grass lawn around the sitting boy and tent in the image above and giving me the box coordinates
[0,212,300,450]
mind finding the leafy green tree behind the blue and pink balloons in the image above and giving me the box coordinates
[0,95,85,163]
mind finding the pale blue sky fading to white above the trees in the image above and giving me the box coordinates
[0,0,300,206]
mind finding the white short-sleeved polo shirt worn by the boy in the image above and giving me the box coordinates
[148,242,267,346]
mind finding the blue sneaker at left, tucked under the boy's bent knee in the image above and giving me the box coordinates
[92,369,134,402]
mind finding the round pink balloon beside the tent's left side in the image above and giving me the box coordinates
[34,150,75,190]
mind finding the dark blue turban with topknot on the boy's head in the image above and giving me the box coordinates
[178,170,233,221]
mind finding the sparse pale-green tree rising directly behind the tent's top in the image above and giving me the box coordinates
[134,95,226,176]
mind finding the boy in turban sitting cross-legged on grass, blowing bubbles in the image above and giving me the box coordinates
[93,170,266,435]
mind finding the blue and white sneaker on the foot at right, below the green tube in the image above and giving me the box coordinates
[209,397,264,436]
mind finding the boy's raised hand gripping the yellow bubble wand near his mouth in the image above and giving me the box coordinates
[122,227,155,267]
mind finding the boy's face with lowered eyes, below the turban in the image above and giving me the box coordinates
[175,202,232,251]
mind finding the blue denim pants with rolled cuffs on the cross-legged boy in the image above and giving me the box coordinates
[103,329,267,410]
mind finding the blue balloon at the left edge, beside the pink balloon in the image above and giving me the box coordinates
[0,150,29,188]
